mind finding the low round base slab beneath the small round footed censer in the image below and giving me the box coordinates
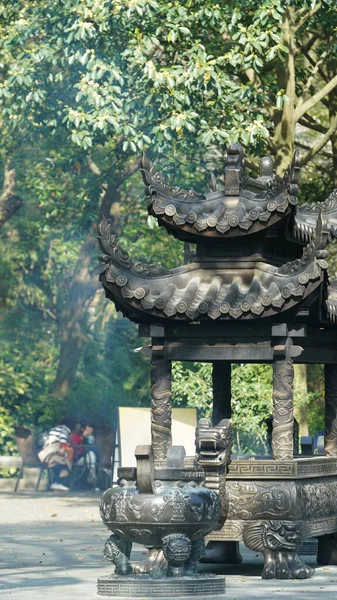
[97,574,226,600]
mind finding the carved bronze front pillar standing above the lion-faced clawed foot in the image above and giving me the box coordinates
[272,359,294,460]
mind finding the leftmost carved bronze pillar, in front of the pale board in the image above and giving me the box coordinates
[151,356,172,461]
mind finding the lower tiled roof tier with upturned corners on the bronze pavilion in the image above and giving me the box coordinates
[99,217,328,320]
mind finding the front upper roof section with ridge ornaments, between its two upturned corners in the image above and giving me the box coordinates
[141,144,300,237]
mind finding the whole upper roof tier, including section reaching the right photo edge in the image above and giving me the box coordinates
[141,144,337,245]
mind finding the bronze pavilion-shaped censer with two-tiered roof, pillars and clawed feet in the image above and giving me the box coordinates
[96,145,337,578]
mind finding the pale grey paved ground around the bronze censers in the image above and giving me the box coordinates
[0,492,337,600]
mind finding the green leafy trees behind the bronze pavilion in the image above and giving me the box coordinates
[0,0,337,452]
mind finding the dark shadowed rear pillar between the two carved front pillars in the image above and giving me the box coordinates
[212,360,232,425]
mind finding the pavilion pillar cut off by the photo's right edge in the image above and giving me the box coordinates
[324,365,337,456]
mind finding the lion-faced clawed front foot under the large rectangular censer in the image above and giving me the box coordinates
[243,521,314,579]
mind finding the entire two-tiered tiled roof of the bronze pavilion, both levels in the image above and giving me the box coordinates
[99,145,337,326]
